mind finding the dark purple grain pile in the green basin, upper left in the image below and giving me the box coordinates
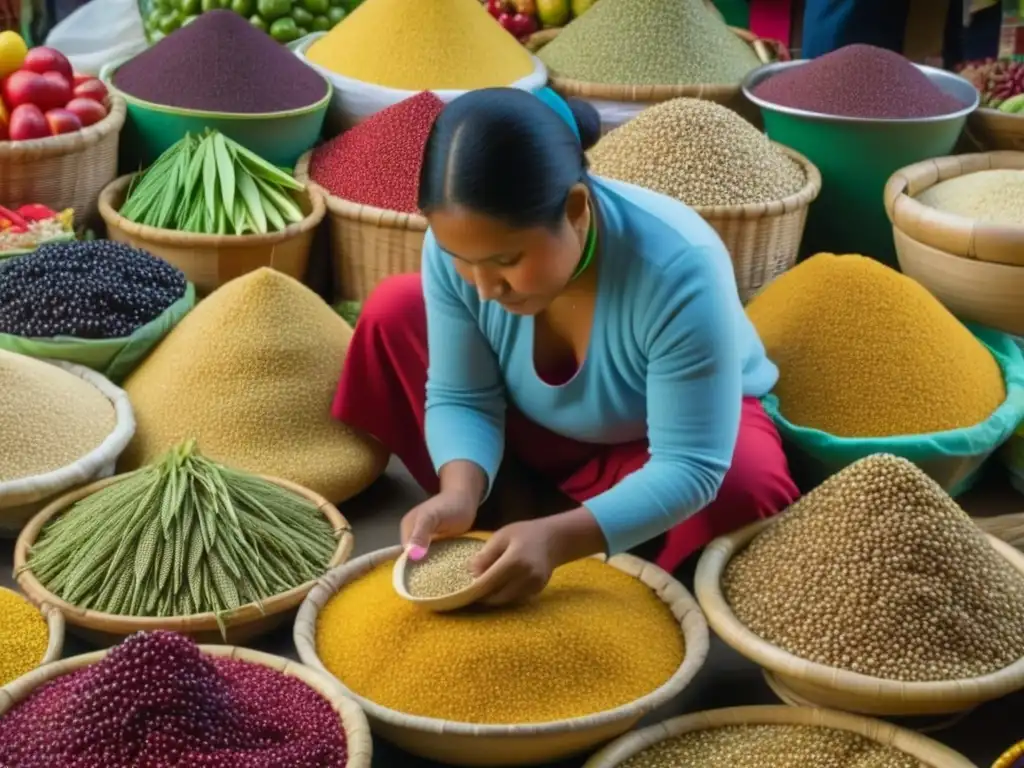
[114,10,327,115]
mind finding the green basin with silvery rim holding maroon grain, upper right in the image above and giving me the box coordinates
[742,59,978,269]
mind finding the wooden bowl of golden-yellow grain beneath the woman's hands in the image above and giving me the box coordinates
[295,547,708,766]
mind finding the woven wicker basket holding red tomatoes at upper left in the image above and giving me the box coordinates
[0,95,126,224]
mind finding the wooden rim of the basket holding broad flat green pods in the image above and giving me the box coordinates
[98,171,327,249]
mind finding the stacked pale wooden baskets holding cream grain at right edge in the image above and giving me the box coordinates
[885,152,1024,335]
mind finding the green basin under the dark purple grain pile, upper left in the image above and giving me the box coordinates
[99,59,325,168]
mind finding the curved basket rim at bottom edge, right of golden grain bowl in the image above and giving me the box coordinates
[583,707,976,768]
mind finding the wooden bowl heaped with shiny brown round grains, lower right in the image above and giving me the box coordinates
[695,454,1024,716]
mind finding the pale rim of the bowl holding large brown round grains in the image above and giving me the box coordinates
[694,516,1024,709]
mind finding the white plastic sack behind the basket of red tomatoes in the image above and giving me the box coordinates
[46,0,147,76]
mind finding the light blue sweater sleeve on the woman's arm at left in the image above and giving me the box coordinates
[423,232,505,493]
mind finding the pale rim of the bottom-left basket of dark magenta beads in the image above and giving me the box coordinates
[0,645,374,768]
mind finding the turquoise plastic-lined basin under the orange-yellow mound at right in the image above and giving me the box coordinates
[762,324,1024,496]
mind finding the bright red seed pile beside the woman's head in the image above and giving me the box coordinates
[309,91,444,213]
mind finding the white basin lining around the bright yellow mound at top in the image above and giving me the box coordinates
[289,32,548,132]
